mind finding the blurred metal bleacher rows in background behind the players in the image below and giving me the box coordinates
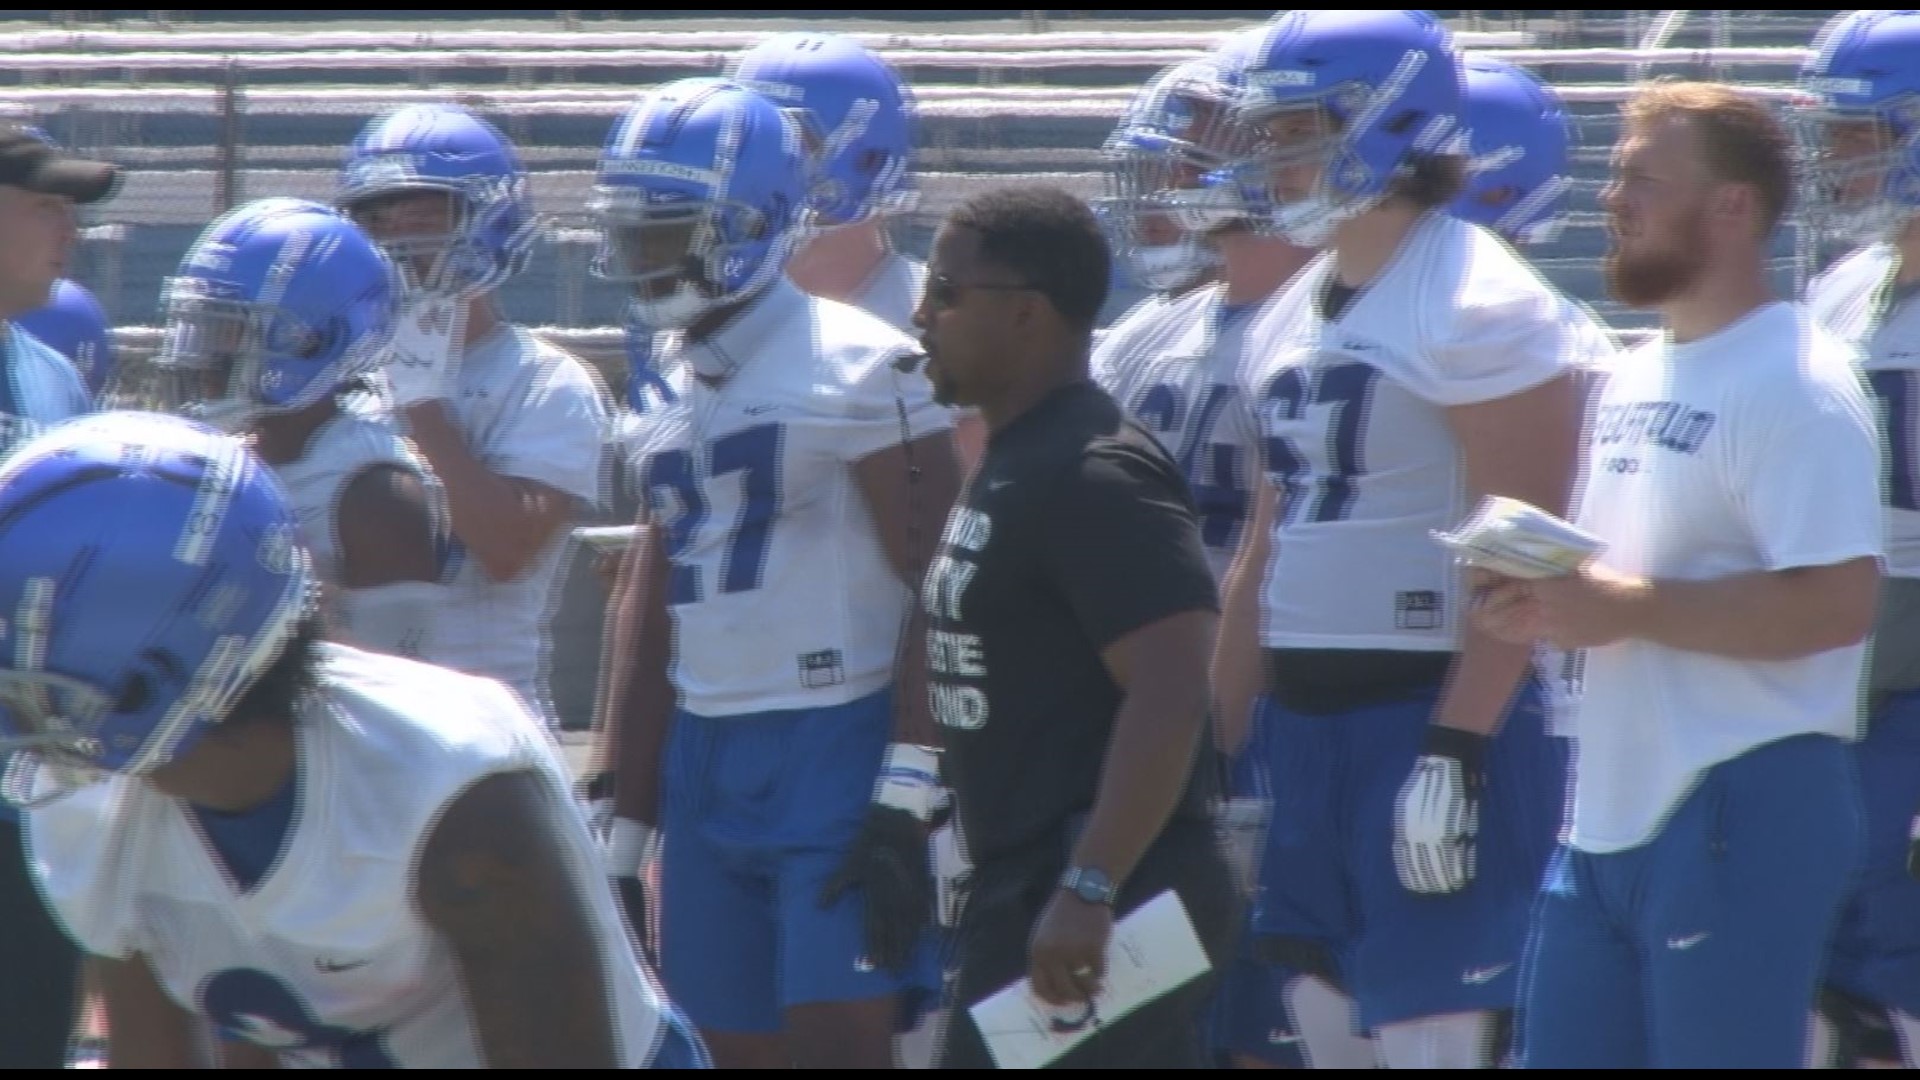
[0,10,1834,728]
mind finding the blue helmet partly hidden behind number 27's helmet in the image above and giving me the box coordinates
[730,33,920,229]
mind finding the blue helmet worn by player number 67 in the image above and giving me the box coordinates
[1210,10,1467,248]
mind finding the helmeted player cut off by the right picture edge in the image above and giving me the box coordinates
[1797,12,1920,1067]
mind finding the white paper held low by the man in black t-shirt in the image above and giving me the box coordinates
[972,890,1212,1068]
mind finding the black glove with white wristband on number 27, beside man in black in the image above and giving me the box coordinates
[820,744,939,974]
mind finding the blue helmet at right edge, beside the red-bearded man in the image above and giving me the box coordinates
[1795,12,1920,242]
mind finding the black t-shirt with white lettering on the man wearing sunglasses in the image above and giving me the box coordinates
[922,382,1219,865]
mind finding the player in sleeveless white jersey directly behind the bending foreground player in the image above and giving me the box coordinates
[154,198,445,663]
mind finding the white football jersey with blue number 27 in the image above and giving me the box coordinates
[637,279,952,717]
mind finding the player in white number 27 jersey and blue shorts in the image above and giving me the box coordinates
[591,79,958,1068]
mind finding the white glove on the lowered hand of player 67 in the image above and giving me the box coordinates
[1394,724,1486,896]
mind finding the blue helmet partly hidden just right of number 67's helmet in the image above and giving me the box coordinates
[1453,56,1574,244]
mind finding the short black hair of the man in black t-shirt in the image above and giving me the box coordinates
[947,184,1114,336]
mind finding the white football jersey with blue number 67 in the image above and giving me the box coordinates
[1240,213,1613,651]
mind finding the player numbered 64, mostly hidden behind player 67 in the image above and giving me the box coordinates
[1092,39,1371,1068]
